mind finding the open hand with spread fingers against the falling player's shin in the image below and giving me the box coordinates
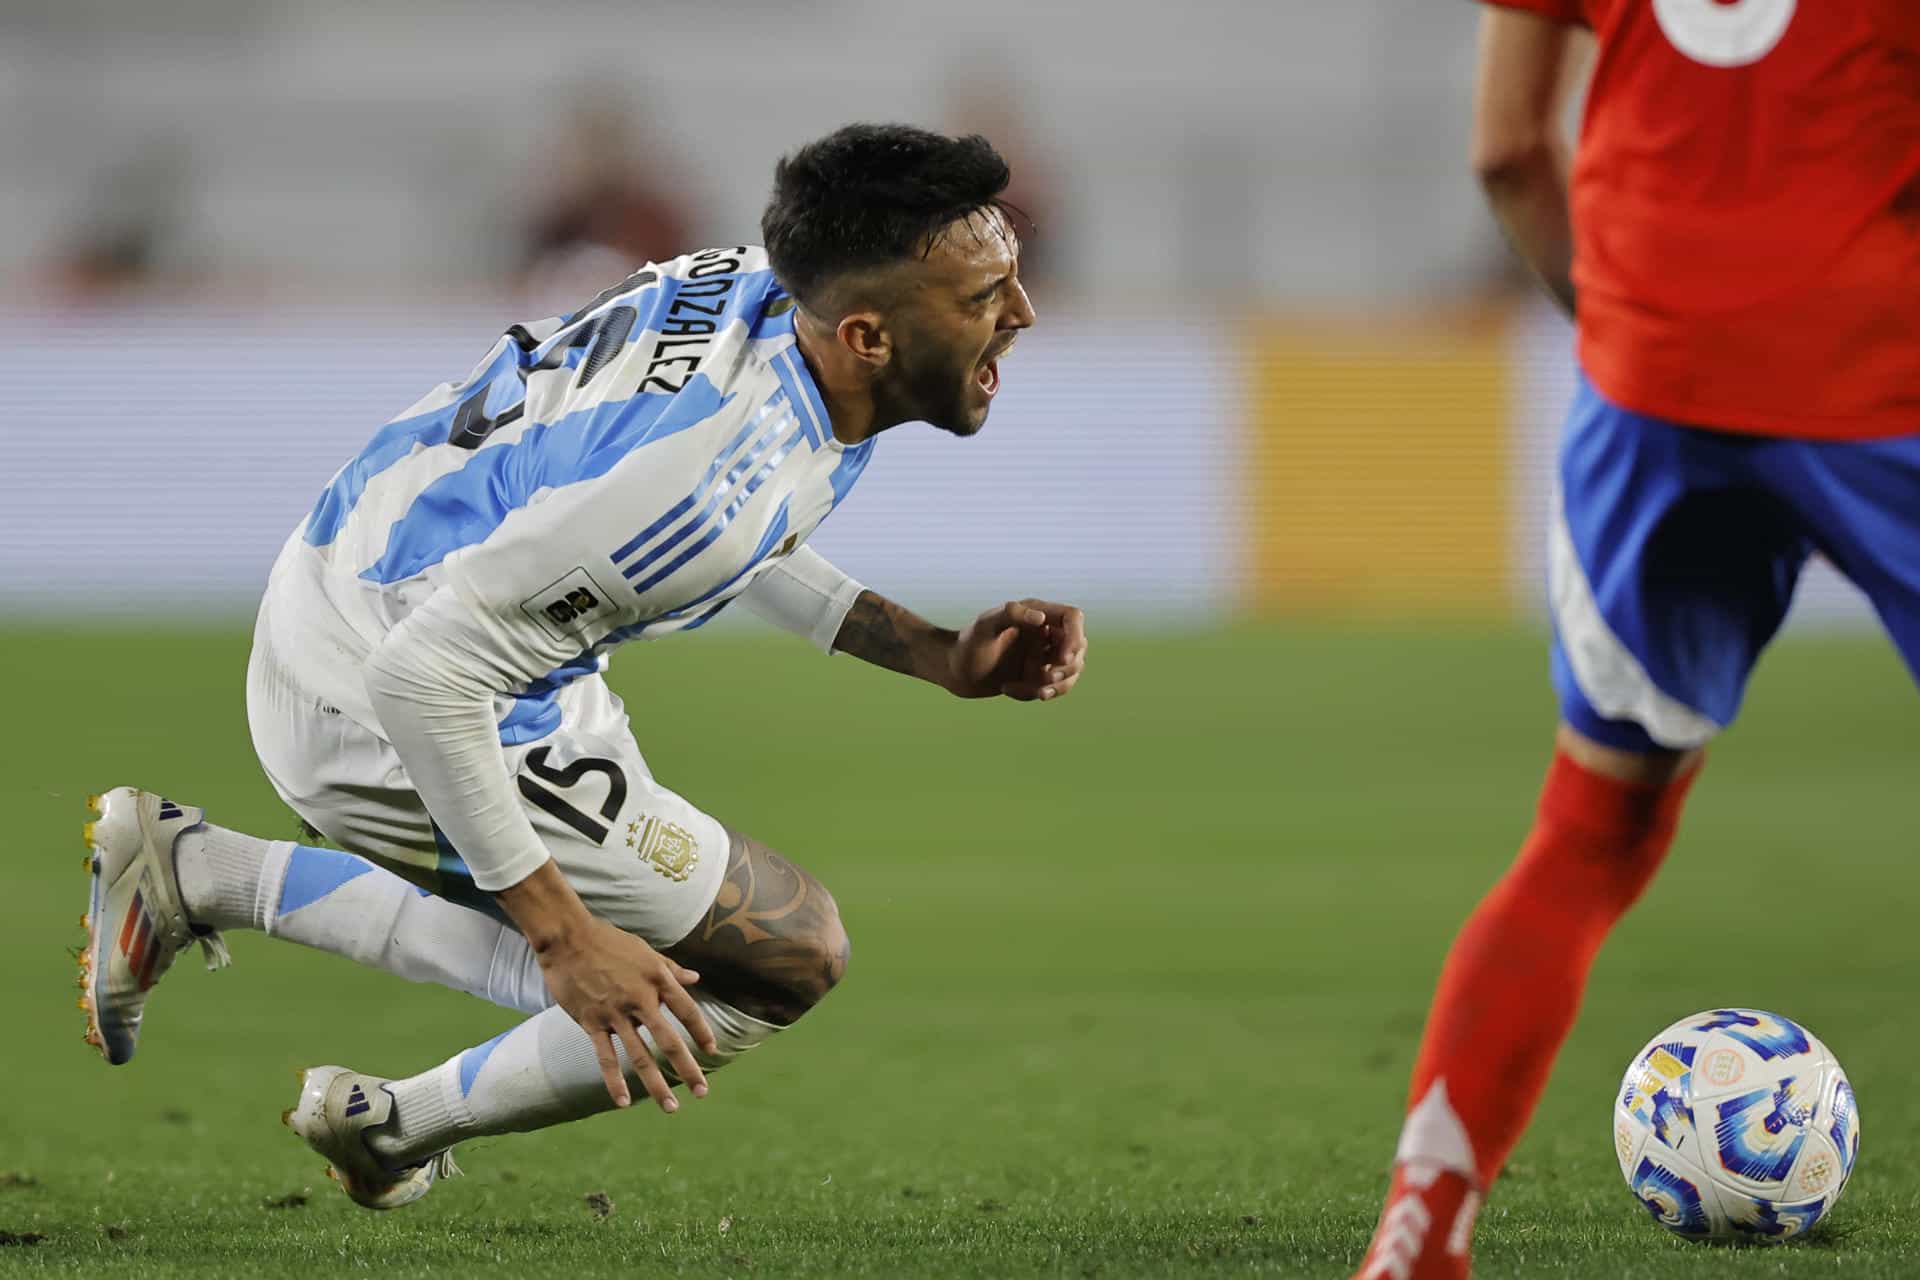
[540,917,714,1113]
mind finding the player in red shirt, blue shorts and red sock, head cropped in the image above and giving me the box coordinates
[1359,0,1920,1280]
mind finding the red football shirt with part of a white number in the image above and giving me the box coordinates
[1488,0,1920,439]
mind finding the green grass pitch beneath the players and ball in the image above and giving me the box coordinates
[0,618,1920,1280]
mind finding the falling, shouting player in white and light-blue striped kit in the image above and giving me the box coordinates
[83,125,1087,1209]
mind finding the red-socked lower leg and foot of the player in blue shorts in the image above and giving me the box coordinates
[1359,729,1697,1280]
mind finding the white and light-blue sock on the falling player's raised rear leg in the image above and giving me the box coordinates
[175,825,553,1013]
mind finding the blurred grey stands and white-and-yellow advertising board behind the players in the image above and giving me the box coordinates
[0,0,1873,622]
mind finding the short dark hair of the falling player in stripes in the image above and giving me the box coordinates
[760,125,1010,305]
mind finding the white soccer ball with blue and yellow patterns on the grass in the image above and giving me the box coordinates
[1613,1009,1860,1242]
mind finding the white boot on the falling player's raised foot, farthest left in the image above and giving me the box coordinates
[79,787,232,1065]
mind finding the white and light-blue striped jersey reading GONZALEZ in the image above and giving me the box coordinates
[269,248,872,745]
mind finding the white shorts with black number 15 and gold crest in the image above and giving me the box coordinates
[246,606,730,946]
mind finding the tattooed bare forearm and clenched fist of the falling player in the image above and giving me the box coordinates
[833,589,1087,700]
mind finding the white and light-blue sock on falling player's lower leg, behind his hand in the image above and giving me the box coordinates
[367,992,780,1169]
